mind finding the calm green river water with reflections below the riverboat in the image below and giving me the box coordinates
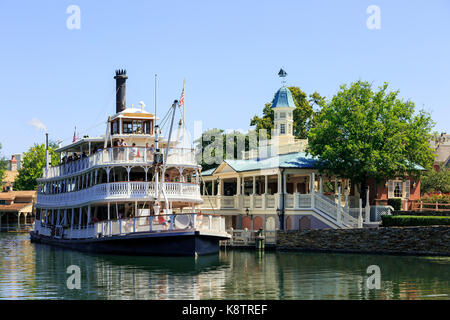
[0,232,450,300]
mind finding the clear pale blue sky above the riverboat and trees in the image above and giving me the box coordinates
[0,0,450,157]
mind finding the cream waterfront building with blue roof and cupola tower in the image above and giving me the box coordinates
[196,70,420,232]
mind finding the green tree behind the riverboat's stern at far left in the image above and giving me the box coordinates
[14,142,60,190]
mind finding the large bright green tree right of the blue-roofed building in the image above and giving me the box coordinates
[307,81,434,202]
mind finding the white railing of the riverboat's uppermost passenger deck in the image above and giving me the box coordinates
[42,147,197,179]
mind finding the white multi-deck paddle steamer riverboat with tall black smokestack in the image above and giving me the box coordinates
[30,70,230,255]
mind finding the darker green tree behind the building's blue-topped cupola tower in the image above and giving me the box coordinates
[250,87,324,139]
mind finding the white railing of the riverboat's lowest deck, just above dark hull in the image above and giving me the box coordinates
[35,213,226,239]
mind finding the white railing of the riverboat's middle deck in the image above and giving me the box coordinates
[36,182,202,207]
